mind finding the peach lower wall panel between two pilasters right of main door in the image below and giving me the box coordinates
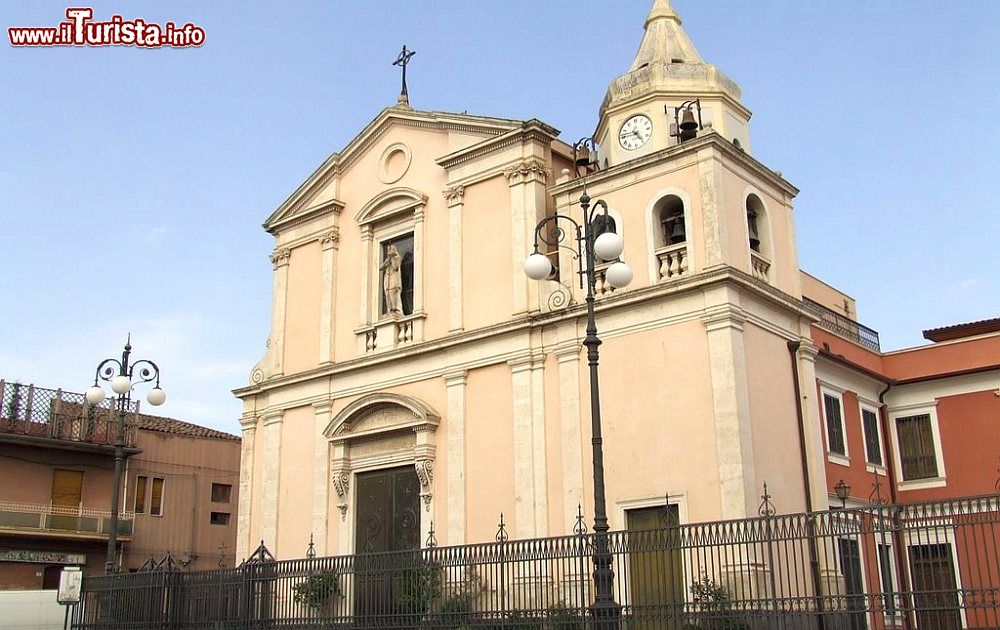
[465,364,517,542]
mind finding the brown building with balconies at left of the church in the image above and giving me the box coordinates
[0,381,240,590]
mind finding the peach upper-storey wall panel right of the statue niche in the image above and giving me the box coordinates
[458,176,513,330]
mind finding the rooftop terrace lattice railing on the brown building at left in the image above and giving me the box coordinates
[0,381,139,446]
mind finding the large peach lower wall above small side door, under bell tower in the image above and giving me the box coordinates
[581,321,720,527]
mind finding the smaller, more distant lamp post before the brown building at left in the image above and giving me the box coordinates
[86,335,167,573]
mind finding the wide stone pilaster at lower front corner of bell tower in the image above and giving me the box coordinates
[702,304,757,519]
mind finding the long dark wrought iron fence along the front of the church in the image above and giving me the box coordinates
[73,496,1000,630]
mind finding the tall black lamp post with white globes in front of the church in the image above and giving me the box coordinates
[524,138,632,630]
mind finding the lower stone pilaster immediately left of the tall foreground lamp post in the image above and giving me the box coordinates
[553,341,583,534]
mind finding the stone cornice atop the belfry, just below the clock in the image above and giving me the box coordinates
[549,133,799,197]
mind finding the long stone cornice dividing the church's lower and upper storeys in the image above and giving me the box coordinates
[232,266,815,404]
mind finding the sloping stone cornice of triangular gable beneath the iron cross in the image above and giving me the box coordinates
[264,106,524,234]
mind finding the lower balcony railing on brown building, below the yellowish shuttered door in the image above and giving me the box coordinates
[0,501,135,536]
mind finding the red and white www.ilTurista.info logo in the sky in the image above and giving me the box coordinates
[7,7,205,48]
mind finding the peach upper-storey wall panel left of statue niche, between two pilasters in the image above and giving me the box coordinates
[284,241,322,374]
